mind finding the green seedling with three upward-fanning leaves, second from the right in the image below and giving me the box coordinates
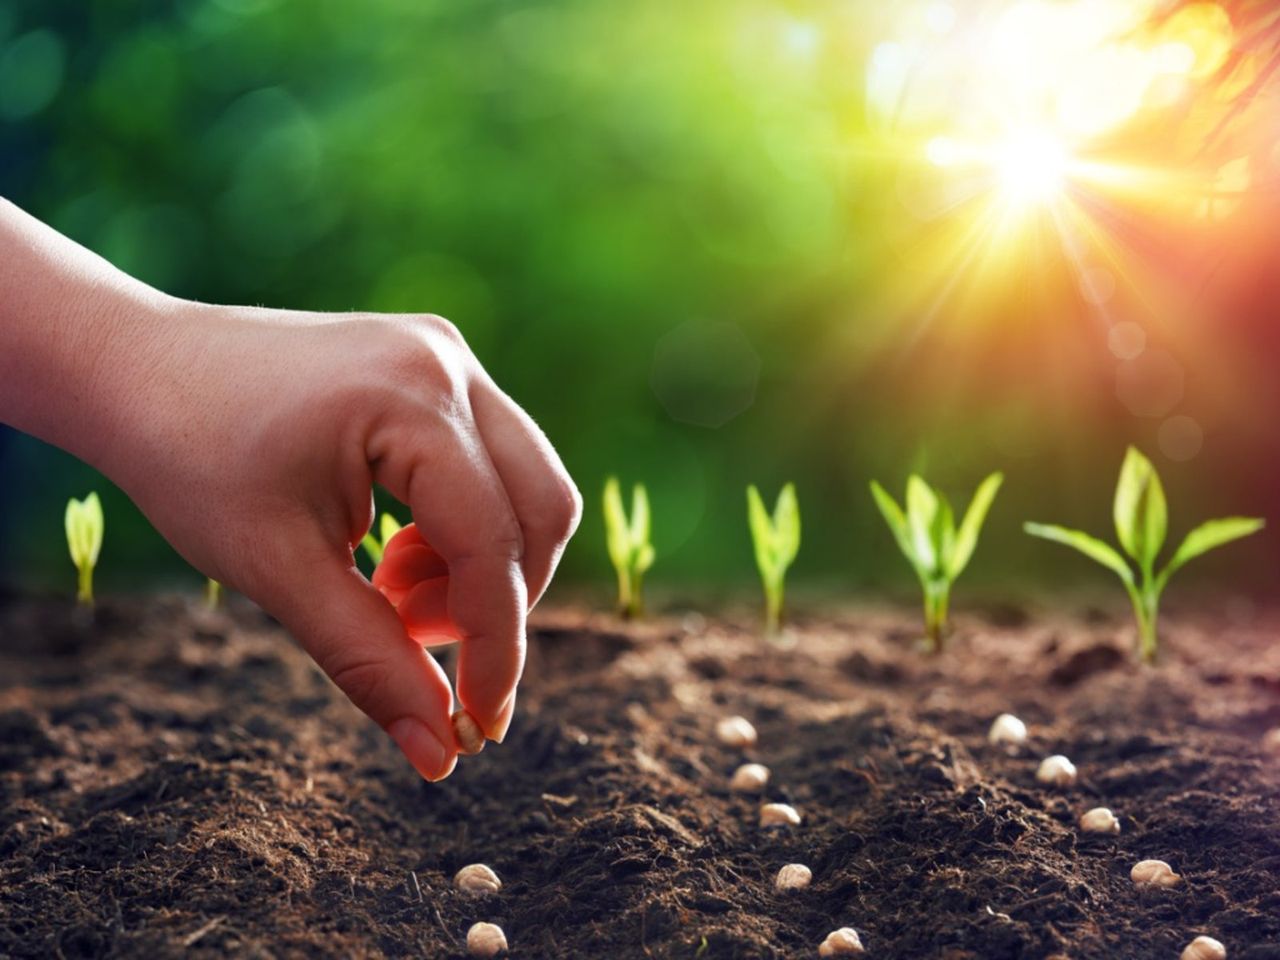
[872,474,1005,653]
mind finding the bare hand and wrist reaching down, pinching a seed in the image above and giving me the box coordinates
[0,198,581,781]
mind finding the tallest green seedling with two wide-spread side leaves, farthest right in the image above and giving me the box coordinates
[1023,447,1265,663]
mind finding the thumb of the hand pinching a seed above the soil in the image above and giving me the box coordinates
[260,545,457,781]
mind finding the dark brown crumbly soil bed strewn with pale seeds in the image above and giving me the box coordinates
[0,598,1280,960]
